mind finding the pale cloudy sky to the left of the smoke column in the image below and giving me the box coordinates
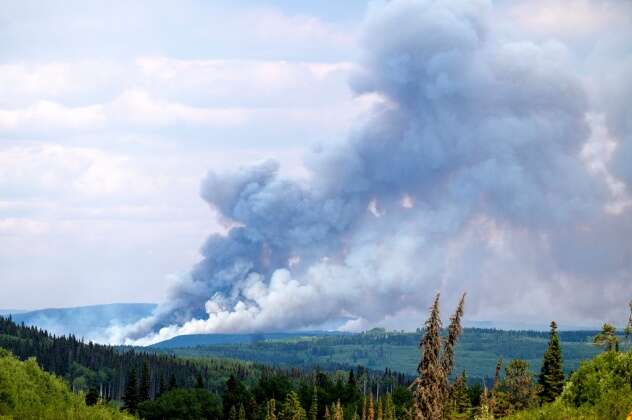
[0,1,365,308]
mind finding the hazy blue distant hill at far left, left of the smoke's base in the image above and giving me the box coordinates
[11,303,156,340]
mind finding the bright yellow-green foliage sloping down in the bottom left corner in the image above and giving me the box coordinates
[0,349,130,420]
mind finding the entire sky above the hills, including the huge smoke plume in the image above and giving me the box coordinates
[0,0,632,342]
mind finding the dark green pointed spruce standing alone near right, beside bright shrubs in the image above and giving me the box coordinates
[538,321,564,402]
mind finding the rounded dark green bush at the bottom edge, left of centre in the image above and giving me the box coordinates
[138,388,223,420]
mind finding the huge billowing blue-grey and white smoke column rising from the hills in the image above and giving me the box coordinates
[119,0,632,343]
